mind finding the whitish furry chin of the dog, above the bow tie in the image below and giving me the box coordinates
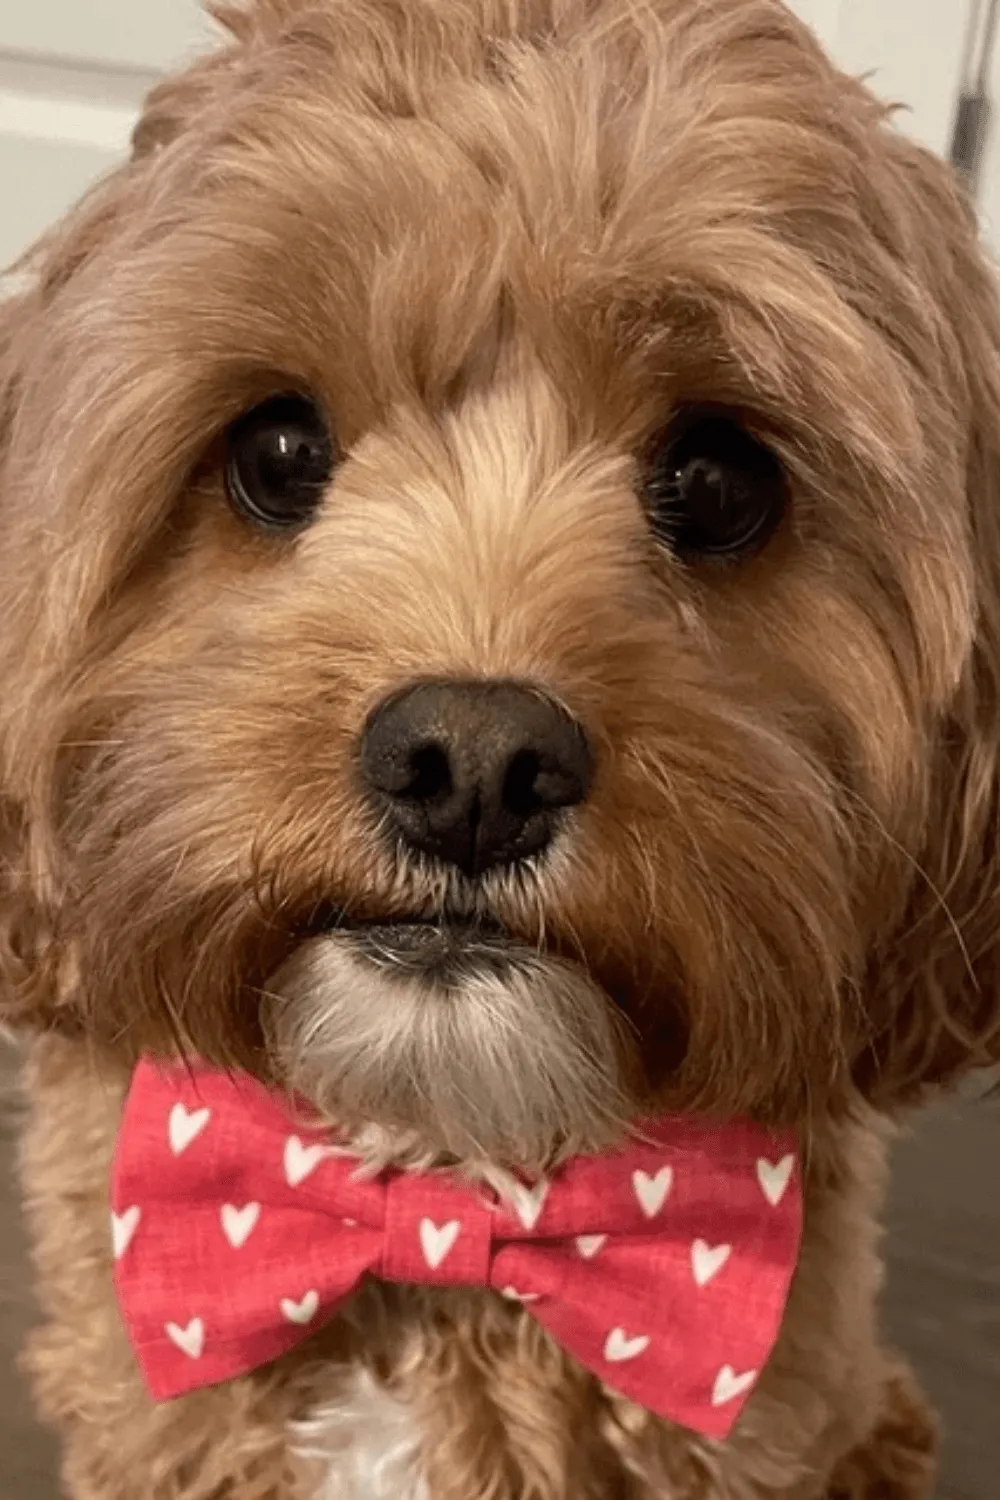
[267,923,636,1173]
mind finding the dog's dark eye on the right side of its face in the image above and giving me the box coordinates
[645,413,787,558]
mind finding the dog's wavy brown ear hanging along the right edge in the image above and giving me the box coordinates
[858,141,1000,1104]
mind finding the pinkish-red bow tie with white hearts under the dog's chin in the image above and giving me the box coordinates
[111,1062,802,1439]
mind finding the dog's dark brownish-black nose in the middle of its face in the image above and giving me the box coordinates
[361,681,591,875]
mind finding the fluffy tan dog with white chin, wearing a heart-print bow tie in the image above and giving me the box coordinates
[0,0,1000,1500]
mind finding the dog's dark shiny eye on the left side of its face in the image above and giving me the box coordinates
[226,395,337,531]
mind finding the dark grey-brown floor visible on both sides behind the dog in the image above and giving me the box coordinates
[0,1055,1000,1500]
